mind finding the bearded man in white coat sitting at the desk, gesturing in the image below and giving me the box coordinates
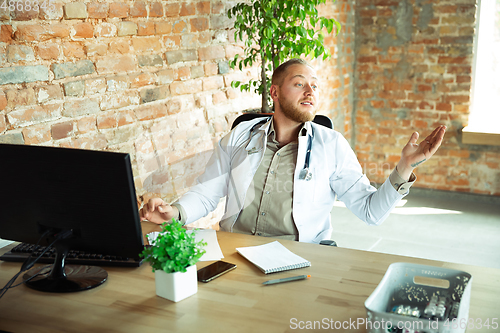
[140,59,446,243]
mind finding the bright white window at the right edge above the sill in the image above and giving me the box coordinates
[468,0,500,133]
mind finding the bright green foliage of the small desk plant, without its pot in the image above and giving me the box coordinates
[140,219,207,273]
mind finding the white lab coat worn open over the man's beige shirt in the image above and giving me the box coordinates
[178,118,407,243]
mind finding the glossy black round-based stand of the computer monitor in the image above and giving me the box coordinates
[23,241,108,293]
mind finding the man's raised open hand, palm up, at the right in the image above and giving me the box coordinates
[396,125,446,179]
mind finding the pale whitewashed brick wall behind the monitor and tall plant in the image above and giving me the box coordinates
[0,0,354,224]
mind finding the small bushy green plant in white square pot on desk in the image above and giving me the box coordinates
[141,219,207,302]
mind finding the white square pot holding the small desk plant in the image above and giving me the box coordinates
[155,265,198,302]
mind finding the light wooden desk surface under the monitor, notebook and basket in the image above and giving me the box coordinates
[0,223,500,333]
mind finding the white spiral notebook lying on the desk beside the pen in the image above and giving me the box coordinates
[236,241,311,274]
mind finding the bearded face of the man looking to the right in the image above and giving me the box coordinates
[271,64,319,123]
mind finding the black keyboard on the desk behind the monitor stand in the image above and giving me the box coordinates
[0,243,142,267]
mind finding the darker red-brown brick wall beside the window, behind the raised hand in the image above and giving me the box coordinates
[352,0,500,195]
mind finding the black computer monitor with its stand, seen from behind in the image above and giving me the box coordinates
[0,144,144,292]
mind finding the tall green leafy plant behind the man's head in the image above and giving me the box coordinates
[227,0,341,112]
